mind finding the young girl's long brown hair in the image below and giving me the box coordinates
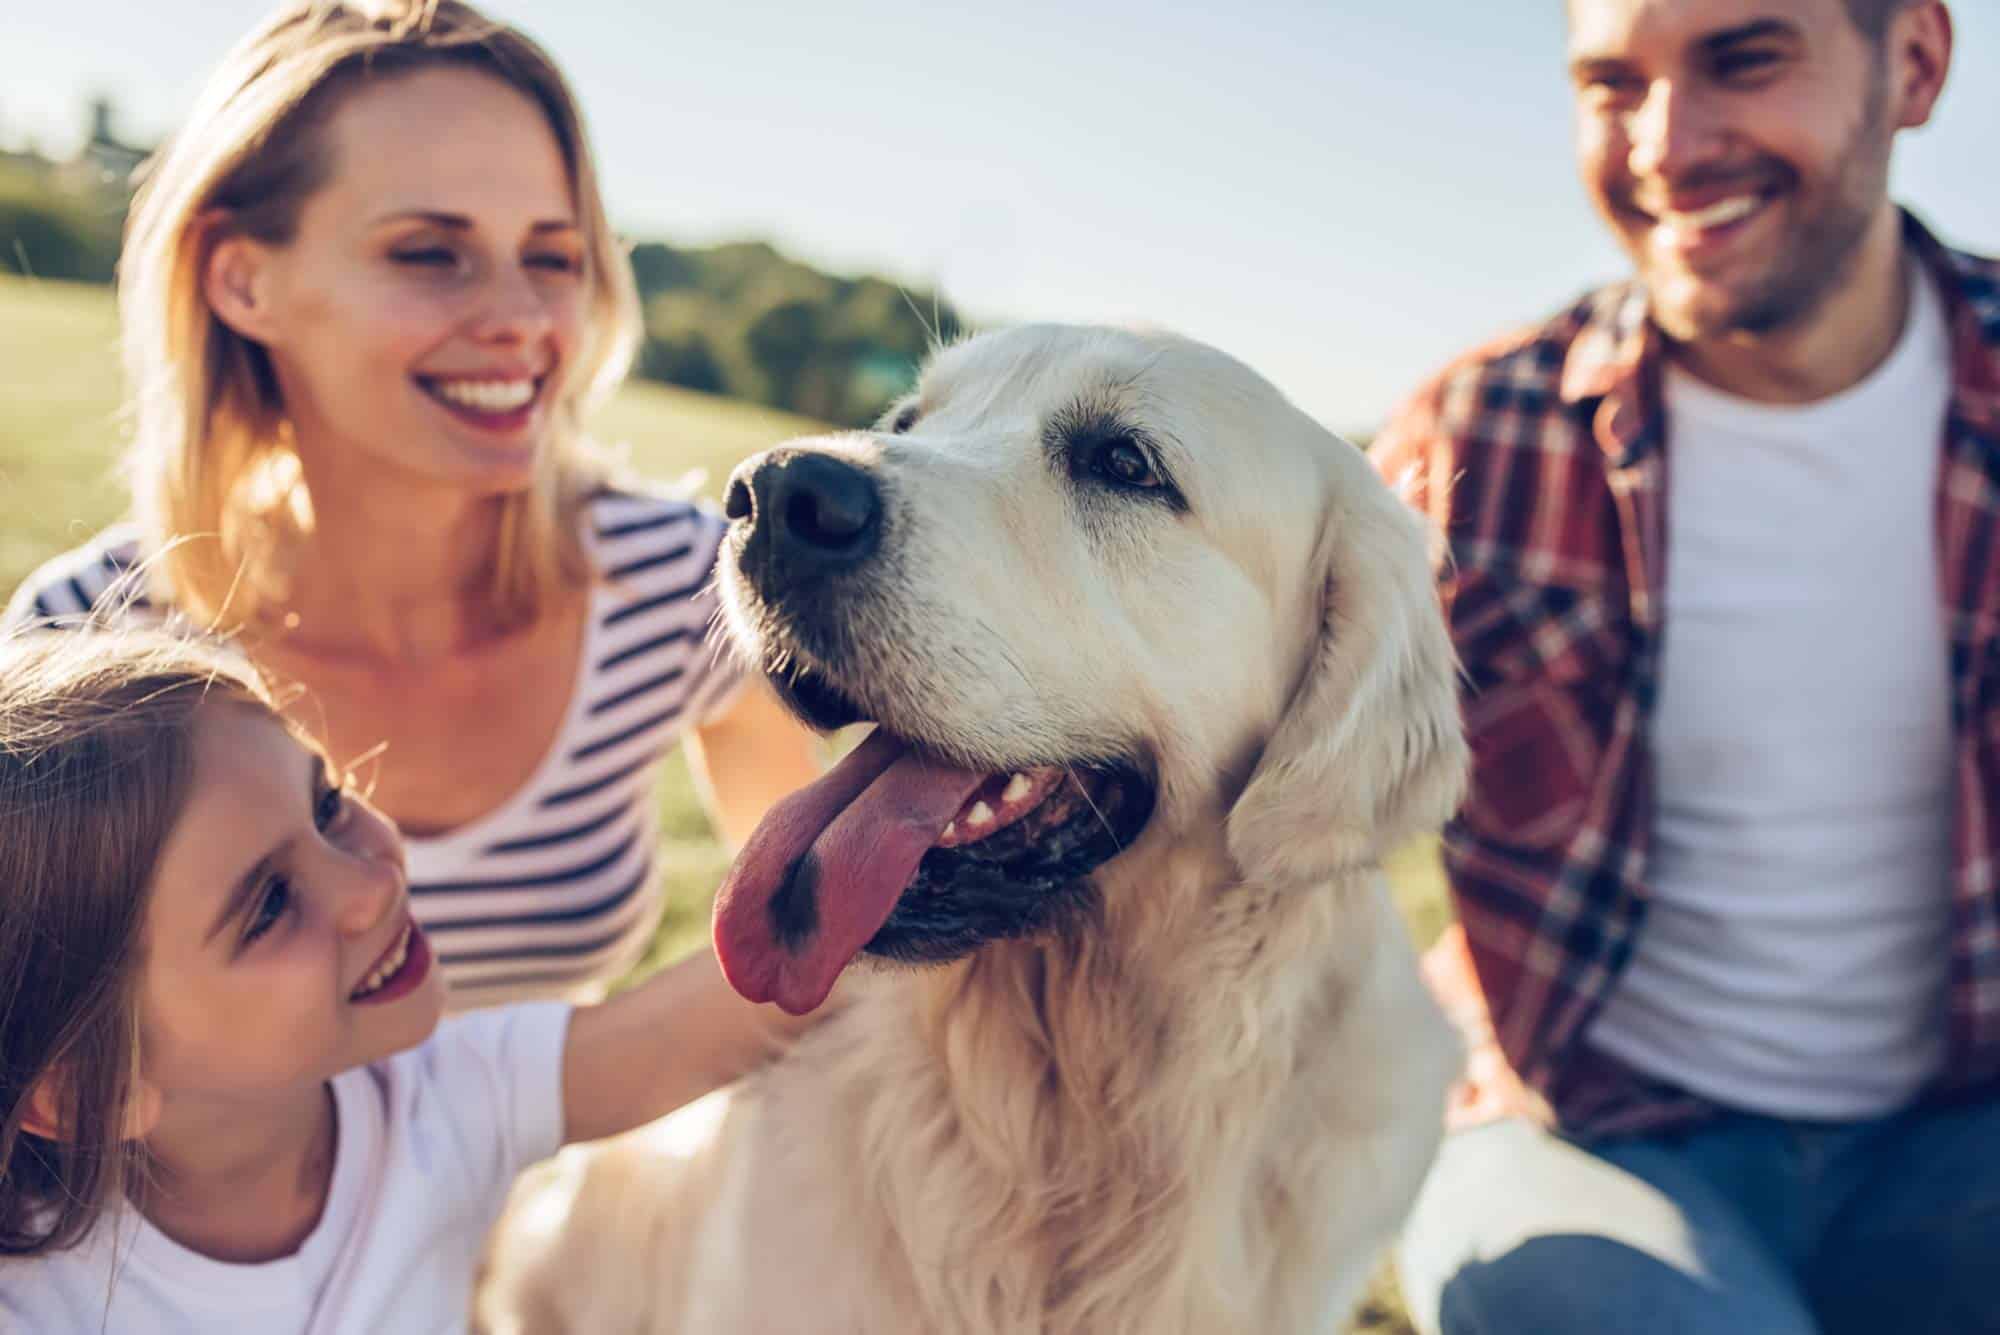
[0,630,278,1257]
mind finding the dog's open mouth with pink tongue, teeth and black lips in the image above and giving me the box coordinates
[714,673,1154,1015]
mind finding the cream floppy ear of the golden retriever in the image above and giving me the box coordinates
[1228,469,1468,885]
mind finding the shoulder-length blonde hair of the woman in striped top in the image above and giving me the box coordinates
[118,0,640,628]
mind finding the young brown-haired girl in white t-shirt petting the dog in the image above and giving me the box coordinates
[0,632,812,1335]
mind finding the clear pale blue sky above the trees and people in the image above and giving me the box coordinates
[0,0,2000,430]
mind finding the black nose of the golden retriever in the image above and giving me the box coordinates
[724,450,882,584]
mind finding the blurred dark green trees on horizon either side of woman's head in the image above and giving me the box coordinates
[0,116,960,426]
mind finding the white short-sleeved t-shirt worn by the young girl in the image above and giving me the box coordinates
[0,1001,570,1335]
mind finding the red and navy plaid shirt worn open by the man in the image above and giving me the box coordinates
[1374,218,2000,1135]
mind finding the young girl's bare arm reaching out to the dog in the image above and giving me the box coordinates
[562,947,828,1143]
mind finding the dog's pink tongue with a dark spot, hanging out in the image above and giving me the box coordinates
[714,727,986,1015]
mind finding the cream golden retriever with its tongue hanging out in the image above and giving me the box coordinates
[482,326,1466,1335]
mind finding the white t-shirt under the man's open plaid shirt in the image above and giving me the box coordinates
[1586,266,1952,1119]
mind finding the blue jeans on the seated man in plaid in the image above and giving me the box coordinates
[1396,1101,2000,1335]
